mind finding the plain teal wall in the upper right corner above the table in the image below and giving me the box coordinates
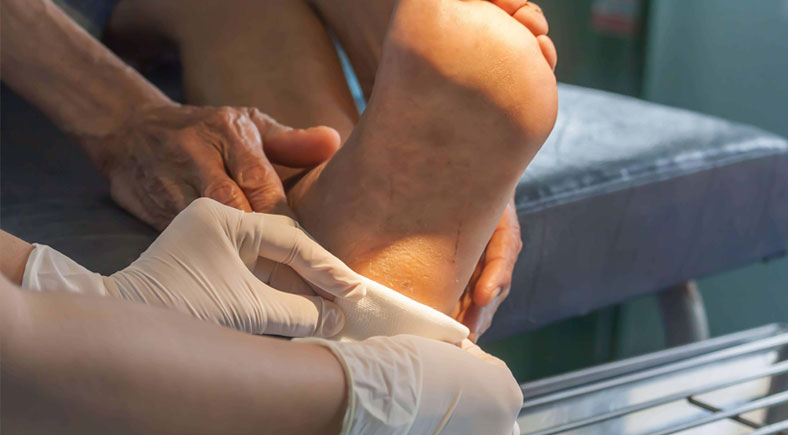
[644,0,788,136]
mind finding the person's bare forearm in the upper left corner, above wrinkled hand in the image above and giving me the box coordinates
[1,0,171,161]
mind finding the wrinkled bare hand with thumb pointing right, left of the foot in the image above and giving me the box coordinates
[88,105,339,229]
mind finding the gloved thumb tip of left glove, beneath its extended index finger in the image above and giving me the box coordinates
[260,287,345,337]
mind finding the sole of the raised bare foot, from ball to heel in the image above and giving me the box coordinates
[289,0,557,312]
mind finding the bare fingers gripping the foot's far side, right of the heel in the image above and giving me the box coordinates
[452,198,523,342]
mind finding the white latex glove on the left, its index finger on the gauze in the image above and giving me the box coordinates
[22,198,365,337]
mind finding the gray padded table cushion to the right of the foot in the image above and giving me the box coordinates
[485,85,788,339]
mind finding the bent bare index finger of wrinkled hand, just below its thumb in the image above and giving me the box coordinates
[224,111,291,214]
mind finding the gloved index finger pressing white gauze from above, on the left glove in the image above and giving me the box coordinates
[241,213,366,301]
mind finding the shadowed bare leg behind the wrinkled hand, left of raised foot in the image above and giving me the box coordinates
[110,0,358,139]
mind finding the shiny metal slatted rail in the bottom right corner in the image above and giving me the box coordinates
[518,324,788,435]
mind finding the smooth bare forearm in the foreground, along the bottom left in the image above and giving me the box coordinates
[0,279,345,434]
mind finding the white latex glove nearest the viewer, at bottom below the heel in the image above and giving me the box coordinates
[299,335,523,435]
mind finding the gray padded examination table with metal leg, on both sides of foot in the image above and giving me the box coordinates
[0,81,788,344]
